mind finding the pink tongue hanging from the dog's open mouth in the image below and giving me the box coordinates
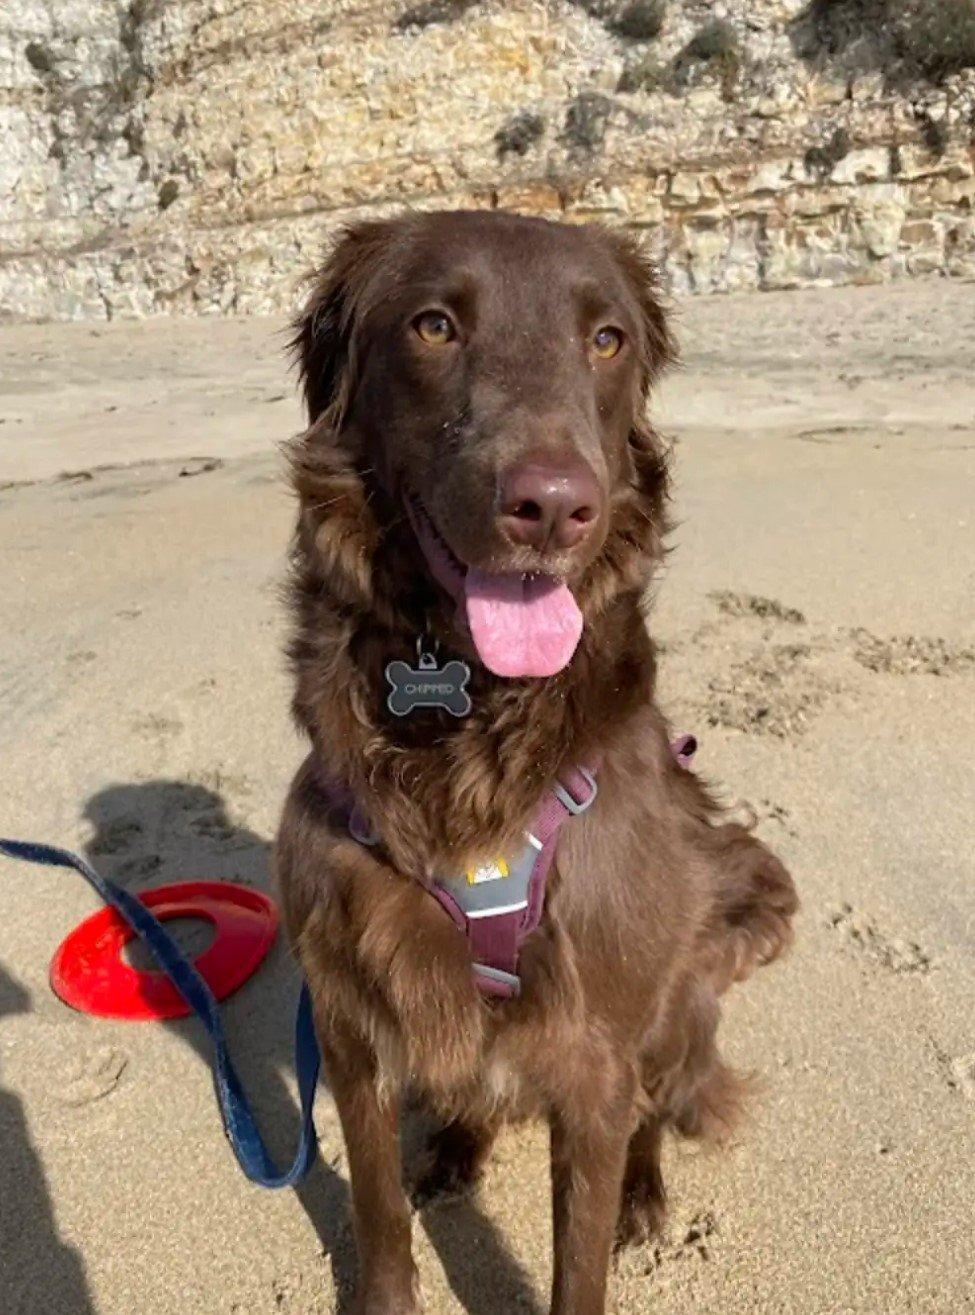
[464,567,583,676]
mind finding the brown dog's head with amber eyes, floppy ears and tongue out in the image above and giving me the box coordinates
[295,212,672,676]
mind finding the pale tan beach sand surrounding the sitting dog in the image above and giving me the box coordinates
[0,281,975,1315]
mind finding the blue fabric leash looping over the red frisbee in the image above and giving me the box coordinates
[0,839,321,1187]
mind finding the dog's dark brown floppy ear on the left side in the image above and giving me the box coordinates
[289,221,396,429]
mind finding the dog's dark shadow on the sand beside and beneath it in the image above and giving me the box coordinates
[78,780,538,1315]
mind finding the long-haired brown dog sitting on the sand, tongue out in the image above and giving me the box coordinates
[278,213,796,1315]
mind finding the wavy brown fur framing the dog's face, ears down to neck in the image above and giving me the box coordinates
[289,224,674,873]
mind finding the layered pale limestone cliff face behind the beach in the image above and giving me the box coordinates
[0,0,975,318]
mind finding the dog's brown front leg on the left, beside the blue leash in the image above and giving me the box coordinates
[318,1023,418,1315]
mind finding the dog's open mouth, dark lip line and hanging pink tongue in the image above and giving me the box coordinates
[407,497,583,676]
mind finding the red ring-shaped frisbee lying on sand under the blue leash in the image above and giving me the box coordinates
[50,881,278,1018]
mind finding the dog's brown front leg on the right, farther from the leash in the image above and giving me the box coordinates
[551,1074,636,1315]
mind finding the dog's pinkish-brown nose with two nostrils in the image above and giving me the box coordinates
[500,458,600,551]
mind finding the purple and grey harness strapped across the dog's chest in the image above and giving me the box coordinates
[339,735,697,999]
